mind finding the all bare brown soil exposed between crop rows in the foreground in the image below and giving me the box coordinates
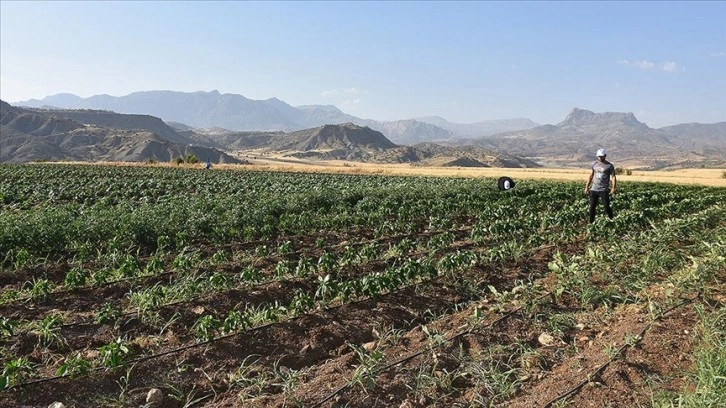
[0,209,721,408]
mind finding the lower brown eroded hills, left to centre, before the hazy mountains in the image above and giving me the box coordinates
[0,101,539,167]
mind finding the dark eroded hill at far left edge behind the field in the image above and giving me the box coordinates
[0,101,241,163]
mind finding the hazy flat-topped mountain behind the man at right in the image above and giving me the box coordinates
[467,108,726,168]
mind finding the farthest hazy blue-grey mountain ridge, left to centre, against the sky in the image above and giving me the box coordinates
[13,90,537,144]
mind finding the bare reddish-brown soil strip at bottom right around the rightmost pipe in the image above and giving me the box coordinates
[507,305,697,408]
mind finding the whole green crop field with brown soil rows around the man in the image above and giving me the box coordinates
[0,164,726,408]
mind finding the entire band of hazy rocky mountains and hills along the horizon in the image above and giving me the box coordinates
[7,91,726,169]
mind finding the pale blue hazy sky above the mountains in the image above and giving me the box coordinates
[0,0,726,127]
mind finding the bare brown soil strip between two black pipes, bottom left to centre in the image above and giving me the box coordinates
[0,282,472,406]
